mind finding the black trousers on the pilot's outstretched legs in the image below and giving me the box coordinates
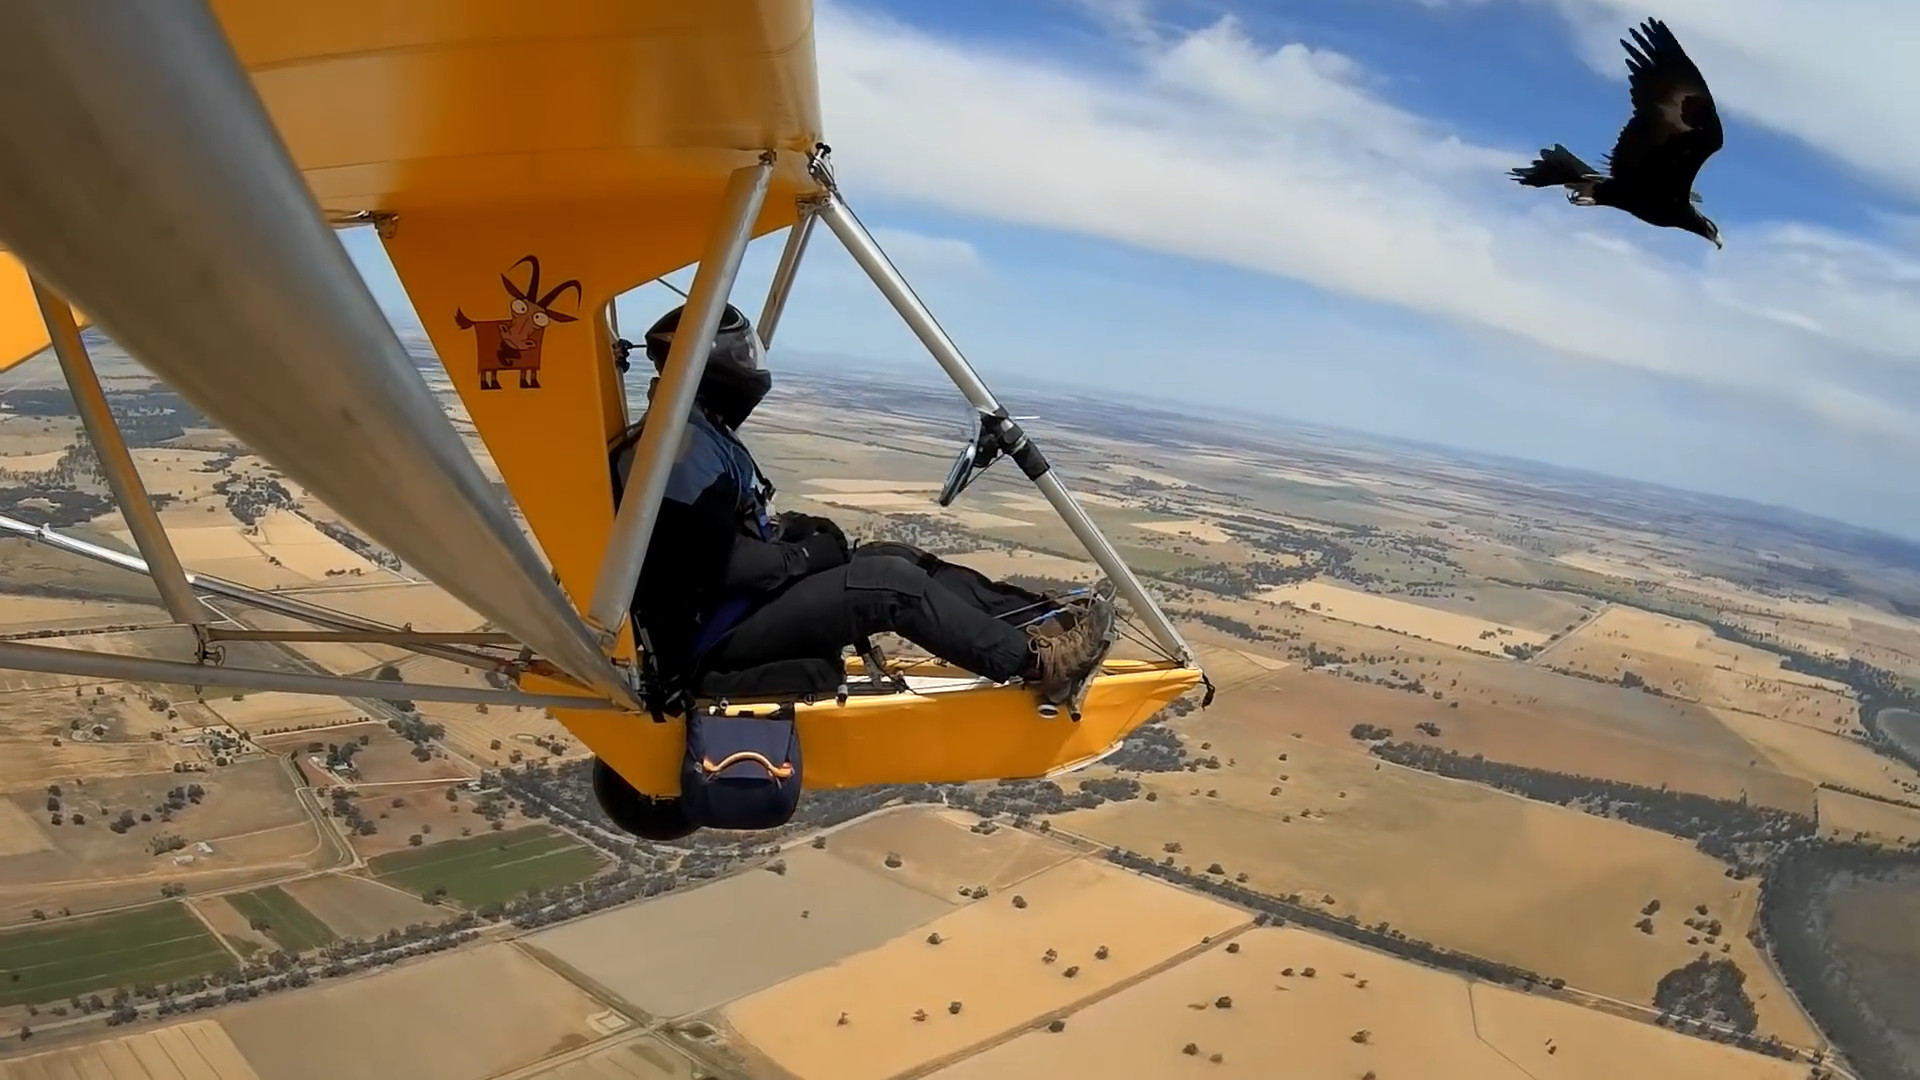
[701,542,1044,682]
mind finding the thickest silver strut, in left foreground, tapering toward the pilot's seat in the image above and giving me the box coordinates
[0,0,641,711]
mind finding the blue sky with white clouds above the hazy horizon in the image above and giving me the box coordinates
[337,0,1920,538]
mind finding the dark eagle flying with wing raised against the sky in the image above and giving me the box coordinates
[1509,19,1724,248]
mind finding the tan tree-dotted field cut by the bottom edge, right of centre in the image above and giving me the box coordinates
[933,928,1805,1080]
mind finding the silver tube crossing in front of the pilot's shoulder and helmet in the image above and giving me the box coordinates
[588,150,774,648]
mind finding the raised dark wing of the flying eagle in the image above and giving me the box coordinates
[1607,19,1724,198]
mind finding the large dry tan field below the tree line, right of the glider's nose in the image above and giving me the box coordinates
[1058,717,1811,1042]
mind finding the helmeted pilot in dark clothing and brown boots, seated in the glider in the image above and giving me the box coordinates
[612,304,1114,703]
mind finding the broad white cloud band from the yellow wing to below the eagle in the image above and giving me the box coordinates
[818,0,1920,440]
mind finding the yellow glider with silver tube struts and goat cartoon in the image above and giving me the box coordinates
[0,0,1204,837]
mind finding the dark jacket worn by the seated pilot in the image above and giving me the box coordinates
[612,407,808,676]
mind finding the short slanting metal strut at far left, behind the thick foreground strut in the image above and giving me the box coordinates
[33,281,213,632]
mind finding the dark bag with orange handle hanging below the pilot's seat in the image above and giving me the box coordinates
[680,705,801,830]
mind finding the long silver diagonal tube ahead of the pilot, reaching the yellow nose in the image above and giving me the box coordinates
[816,188,1194,665]
